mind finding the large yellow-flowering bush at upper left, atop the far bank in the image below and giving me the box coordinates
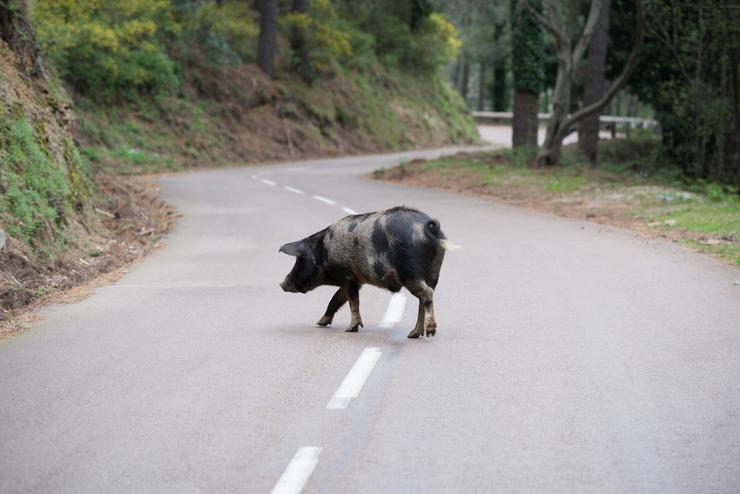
[34,0,179,99]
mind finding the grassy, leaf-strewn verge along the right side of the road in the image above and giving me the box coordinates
[376,132,740,265]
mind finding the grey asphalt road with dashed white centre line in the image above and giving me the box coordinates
[0,147,740,493]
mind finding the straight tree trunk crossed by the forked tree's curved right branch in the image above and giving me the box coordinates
[578,0,611,165]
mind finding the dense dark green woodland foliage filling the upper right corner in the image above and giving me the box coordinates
[610,0,740,187]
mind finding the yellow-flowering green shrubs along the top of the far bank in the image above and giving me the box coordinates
[34,0,460,97]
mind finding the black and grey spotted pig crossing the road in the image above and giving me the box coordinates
[280,206,447,338]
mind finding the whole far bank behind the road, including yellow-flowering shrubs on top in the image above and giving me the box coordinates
[32,0,478,173]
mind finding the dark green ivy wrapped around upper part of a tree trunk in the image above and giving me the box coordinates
[511,0,545,94]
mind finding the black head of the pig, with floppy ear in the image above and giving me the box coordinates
[280,230,326,293]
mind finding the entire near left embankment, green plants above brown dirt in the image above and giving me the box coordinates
[0,26,177,336]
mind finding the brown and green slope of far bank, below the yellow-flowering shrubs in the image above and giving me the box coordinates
[77,65,478,173]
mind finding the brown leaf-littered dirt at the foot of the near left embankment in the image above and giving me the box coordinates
[0,175,179,338]
